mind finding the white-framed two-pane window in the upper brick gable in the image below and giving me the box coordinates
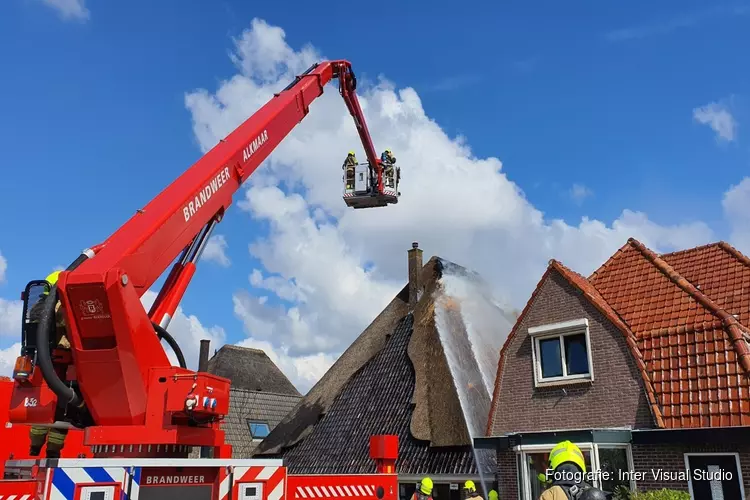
[529,318,594,386]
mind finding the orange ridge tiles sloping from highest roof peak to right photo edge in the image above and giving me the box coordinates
[628,238,750,375]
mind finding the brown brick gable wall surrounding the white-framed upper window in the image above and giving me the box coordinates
[492,271,654,436]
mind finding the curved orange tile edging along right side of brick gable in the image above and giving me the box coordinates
[549,259,665,428]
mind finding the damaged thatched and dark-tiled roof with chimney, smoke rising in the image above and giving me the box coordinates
[256,254,502,474]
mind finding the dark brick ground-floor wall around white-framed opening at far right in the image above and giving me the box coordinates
[632,443,750,495]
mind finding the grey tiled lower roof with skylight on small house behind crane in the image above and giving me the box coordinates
[222,388,302,458]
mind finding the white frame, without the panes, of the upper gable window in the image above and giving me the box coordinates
[528,318,594,387]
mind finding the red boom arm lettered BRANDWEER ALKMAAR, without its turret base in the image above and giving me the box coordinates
[76,61,378,295]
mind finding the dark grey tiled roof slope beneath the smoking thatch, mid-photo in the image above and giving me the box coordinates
[270,314,488,474]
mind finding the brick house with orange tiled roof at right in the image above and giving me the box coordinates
[475,238,750,500]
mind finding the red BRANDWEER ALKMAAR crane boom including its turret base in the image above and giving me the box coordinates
[58,60,382,426]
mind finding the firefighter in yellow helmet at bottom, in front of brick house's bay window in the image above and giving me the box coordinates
[539,441,607,500]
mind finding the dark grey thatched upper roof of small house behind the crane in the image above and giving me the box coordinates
[208,345,301,396]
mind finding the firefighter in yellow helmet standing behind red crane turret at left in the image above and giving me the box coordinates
[29,271,70,458]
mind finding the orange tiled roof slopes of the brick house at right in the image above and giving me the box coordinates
[588,238,750,428]
